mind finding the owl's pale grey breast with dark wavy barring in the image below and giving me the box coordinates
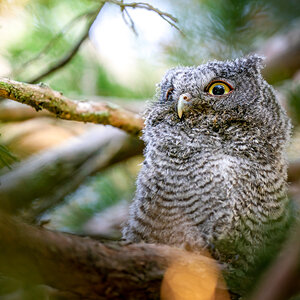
[139,151,243,237]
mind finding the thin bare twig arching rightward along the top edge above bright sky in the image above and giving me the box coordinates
[106,0,183,34]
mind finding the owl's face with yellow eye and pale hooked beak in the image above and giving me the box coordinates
[148,56,267,126]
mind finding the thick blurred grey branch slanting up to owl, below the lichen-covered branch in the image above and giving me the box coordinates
[0,127,143,216]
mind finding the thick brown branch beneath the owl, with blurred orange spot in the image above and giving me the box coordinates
[0,214,228,300]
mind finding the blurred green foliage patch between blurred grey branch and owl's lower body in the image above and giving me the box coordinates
[47,159,136,233]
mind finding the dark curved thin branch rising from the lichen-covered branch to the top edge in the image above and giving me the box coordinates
[28,2,105,83]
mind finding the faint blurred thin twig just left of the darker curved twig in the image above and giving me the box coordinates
[10,9,98,77]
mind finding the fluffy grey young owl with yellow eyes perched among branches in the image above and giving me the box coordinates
[123,55,291,294]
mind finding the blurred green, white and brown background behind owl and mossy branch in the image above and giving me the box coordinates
[0,0,300,298]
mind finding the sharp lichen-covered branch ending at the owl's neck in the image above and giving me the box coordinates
[0,78,144,135]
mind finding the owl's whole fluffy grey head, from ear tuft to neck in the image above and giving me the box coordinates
[144,55,289,159]
